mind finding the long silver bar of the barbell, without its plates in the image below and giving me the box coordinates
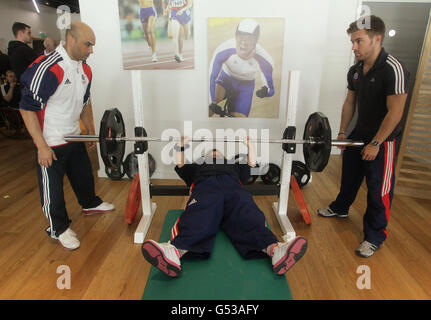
[64,135,364,147]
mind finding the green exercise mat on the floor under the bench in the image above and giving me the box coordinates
[142,210,292,300]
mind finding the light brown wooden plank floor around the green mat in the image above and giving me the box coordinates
[0,138,431,299]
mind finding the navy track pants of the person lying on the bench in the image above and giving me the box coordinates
[171,175,278,259]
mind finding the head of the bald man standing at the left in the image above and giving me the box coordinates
[66,21,96,61]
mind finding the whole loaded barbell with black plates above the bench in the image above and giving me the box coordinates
[64,108,364,171]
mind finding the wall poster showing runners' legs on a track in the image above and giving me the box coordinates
[118,0,195,70]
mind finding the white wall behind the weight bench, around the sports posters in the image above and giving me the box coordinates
[80,0,358,178]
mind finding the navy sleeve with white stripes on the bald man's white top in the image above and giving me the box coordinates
[19,52,64,111]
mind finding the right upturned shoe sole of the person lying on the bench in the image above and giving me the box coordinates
[271,237,308,275]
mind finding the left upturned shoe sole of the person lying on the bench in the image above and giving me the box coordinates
[142,240,181,277]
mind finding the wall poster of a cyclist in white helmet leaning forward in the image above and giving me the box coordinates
[208,18,285,118]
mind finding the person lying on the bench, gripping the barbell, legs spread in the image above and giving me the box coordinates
[142,137,307,277]
